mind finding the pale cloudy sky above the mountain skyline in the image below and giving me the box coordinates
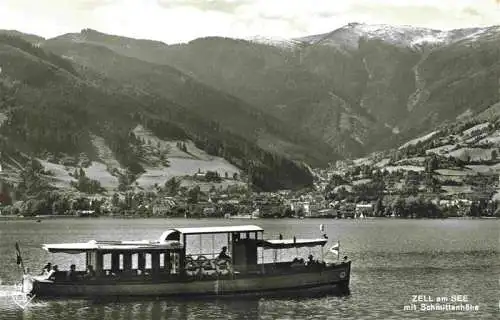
[0,0,500,44]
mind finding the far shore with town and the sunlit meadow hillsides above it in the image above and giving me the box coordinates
[0,109,500,218]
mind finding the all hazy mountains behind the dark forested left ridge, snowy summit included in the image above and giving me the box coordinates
[0,24,500,194]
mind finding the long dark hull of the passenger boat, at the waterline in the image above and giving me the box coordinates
[27,262,350,298]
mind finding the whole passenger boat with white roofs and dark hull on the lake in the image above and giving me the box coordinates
[16,225,351,298]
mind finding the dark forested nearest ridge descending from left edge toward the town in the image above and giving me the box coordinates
[0,34,318,190]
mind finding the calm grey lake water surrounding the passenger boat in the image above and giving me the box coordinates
[0,219,500,320]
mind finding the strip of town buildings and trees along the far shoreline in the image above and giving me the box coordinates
[0,158,500,219]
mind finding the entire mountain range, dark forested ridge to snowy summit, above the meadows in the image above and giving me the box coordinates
[0,23,500,189]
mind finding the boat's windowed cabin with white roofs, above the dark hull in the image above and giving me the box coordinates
[43,225,327,280]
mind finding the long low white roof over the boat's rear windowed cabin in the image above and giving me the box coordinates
[42,240,182,253]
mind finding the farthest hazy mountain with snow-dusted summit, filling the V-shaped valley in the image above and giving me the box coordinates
[52,24,500,157]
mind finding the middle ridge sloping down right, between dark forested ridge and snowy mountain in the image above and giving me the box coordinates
[43,35,336,165]
